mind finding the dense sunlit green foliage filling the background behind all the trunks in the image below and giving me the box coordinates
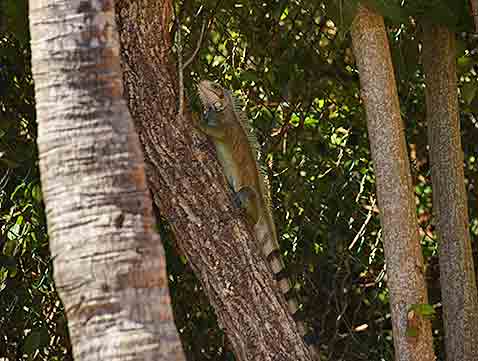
[0,0,478,361]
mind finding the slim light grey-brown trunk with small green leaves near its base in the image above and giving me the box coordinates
[352,6,435,361]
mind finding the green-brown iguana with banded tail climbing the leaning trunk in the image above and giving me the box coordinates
[197,80,312,344]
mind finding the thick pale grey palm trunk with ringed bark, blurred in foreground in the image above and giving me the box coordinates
[30,0,184,360]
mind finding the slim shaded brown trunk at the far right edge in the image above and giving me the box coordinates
[423,25,478,361]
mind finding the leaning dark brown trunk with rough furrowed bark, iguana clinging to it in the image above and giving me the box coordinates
[112,0,310,361]
